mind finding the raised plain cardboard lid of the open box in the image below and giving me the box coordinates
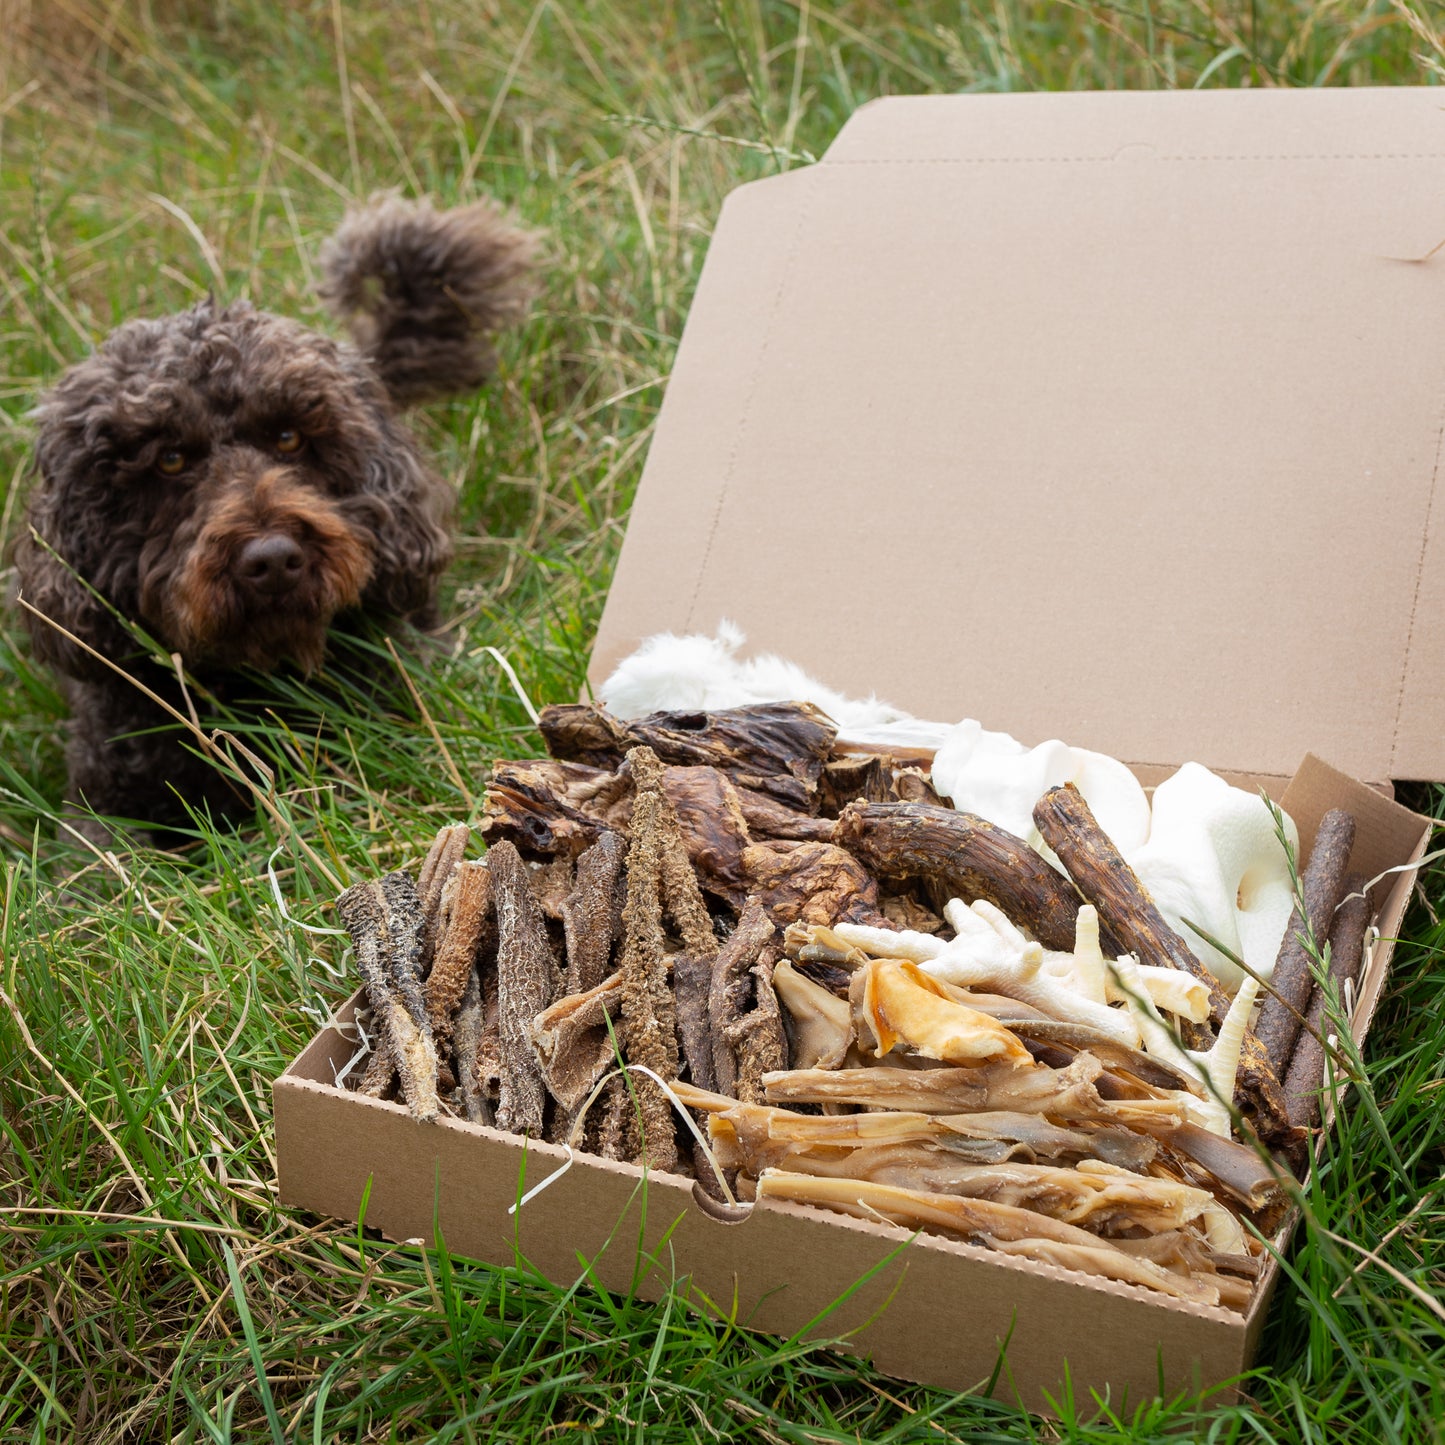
[591,90,1445,780]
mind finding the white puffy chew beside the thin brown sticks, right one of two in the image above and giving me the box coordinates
[1121,763,1299,993]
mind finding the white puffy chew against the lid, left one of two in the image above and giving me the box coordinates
[933,718,1149,867]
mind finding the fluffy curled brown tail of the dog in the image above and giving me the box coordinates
[319,195,539,406]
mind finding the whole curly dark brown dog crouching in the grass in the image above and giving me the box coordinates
[16,198,535,832]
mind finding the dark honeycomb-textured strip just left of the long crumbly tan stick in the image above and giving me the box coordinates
[487,842,558,1137]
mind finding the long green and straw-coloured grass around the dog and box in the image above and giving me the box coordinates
[0,0,1445,1441]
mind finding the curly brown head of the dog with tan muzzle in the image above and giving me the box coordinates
[16,302,451,676]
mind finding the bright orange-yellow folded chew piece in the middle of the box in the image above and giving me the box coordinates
[850,958,1033,1068]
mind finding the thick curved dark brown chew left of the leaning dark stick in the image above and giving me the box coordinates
[835,803,1098,957]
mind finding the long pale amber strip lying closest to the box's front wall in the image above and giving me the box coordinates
[757,1169,1220,1305]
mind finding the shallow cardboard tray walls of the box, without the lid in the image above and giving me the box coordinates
[273,757,1432,1412]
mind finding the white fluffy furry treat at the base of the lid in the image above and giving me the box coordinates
[598,618,913,734]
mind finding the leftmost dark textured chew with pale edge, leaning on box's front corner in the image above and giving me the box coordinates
[337,873,439,1121]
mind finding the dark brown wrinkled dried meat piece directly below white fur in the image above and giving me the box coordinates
[538,702,838,812]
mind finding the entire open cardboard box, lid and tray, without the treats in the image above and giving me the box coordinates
[273,90,1445,1407]
